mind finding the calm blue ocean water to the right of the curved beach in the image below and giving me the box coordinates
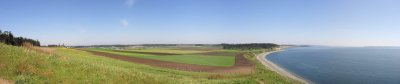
[266,46,400,84]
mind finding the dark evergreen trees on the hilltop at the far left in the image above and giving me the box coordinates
[0,30,40,46]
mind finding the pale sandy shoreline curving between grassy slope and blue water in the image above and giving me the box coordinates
[256,50,311,84]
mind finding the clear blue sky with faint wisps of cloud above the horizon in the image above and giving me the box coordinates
[0,0,400,46]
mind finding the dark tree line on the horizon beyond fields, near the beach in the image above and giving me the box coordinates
[221,43,279,50]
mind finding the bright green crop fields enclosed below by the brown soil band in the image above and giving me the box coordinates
[88,48,236,67]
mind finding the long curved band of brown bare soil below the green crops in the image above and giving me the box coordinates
[81,49,255,74]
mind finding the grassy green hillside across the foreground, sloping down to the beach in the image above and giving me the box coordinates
[0,43,299,84]
